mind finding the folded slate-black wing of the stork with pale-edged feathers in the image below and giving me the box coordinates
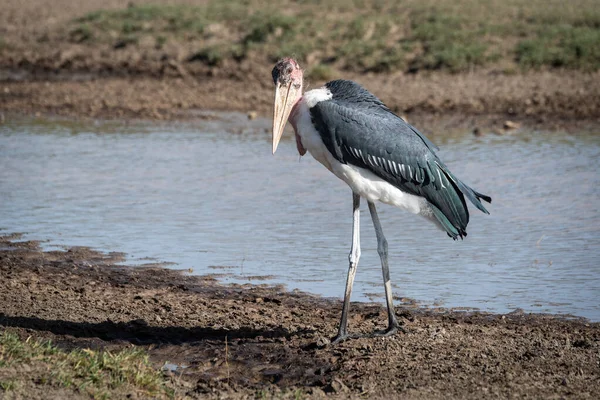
[310,81,491,239]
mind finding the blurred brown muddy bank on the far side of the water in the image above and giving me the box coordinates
[0,71,600,133]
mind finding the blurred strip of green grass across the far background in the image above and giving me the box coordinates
[68,0,600,75]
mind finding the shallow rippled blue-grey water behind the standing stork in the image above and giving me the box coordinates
[0,114,600,321]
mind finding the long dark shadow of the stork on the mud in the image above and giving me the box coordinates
[0,313,302,345]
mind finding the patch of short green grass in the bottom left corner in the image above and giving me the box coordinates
[0,332,172,398]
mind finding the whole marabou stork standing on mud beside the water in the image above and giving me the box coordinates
[272,58,492,343]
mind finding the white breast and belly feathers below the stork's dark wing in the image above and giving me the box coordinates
[294,96,435,222]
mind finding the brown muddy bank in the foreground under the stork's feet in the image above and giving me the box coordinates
[0,237,600,399]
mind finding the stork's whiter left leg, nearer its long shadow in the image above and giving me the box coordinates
[331,193,360,343]
